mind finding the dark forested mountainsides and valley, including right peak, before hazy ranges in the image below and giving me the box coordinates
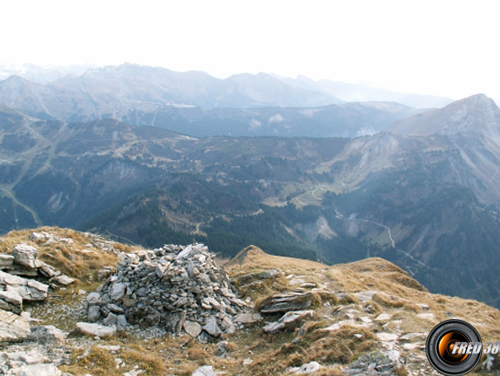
[0,95,500,306]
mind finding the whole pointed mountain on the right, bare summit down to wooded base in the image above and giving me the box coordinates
[317,95,500,305]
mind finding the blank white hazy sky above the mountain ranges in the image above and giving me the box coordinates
[0,0,500,98]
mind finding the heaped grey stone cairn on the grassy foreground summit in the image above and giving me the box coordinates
[87,244,246,337]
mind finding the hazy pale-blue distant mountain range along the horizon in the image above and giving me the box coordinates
[0,64,426,137]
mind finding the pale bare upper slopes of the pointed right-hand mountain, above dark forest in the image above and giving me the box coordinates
[325,94,500,205]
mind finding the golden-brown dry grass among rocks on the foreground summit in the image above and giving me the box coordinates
[6,228,500,376]
